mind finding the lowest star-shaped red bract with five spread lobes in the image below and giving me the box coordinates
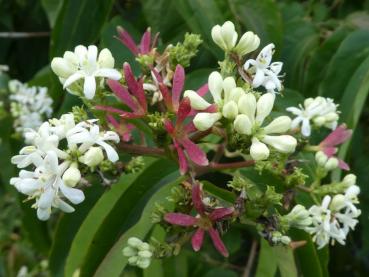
[164,184,234,257]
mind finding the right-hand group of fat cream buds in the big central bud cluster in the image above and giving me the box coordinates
[234,93,297,160]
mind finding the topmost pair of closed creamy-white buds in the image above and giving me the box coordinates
[211,21,260,56]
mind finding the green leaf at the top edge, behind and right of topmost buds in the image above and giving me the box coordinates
[229,0,283,49]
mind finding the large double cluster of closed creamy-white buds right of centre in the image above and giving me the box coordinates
[184,72,297,160]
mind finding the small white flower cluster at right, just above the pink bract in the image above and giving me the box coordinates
[287,96,339,137]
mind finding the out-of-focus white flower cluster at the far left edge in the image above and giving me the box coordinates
[9,80,53,135]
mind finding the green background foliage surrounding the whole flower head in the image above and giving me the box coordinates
[0,0,369,277]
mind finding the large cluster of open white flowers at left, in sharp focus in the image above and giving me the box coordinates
[10,114,119,220]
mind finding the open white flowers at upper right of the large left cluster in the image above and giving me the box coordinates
[67,120,119,162]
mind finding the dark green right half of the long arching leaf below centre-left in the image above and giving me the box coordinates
[80,160,178,276]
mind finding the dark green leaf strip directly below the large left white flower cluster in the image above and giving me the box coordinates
[49,182,104,277]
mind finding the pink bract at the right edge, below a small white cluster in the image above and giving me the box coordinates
[319,124,352,170]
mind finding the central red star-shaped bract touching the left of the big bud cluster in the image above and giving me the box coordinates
[164,97,209,174]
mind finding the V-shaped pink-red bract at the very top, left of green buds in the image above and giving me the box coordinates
[117,27,159,56]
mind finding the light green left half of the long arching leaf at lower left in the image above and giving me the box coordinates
[65,158,171,276]
